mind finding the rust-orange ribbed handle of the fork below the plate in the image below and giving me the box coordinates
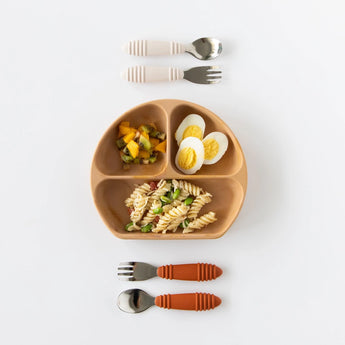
[157,263,223,281]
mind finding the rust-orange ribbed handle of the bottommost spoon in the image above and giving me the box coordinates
[155,292,222,311]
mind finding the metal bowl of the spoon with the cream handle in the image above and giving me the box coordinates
[186,37,223,60]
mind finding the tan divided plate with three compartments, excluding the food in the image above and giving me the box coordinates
[91,99,247,240]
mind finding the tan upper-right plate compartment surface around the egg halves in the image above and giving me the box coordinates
[169,103,243,176]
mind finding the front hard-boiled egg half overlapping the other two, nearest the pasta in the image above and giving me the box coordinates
[175,137,205,175]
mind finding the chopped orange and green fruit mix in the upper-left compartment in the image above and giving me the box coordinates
[116,121,166,168]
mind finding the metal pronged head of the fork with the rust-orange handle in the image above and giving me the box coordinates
[117,261,157,281]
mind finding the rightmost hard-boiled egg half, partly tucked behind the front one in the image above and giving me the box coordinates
[202,132,229,164]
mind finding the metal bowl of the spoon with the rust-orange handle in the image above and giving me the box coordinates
[117,289,155,314]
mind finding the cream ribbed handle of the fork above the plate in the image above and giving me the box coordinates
[121,66,183,83]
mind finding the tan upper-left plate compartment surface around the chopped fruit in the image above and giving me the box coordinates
[94,104,168,176]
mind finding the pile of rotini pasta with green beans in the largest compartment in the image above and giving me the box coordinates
[125,179,216,233]
